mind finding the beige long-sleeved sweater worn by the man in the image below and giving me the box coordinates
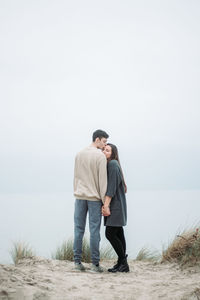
[74,146,107,201]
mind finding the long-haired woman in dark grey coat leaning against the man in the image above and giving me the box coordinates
[102,143,129,273]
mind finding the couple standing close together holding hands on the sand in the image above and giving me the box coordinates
[74,130,129,273]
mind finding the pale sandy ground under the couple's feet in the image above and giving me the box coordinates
[0,257,200,300]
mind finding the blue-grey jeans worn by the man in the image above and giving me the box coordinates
[74,199,102,265]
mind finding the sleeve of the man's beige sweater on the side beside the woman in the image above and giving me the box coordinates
[98,155,107,202]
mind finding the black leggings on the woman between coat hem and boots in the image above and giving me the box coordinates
[105,226,126,259]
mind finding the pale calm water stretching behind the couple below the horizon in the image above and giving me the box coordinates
[0,190,200,263]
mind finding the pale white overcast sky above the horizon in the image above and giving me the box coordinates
[0,0,200,193]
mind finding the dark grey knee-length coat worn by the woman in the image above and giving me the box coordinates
[104,160,127,227]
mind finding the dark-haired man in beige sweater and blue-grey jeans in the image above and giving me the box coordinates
[74,129,109,272]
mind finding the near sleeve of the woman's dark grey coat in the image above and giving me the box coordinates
[106,162,121,198]
